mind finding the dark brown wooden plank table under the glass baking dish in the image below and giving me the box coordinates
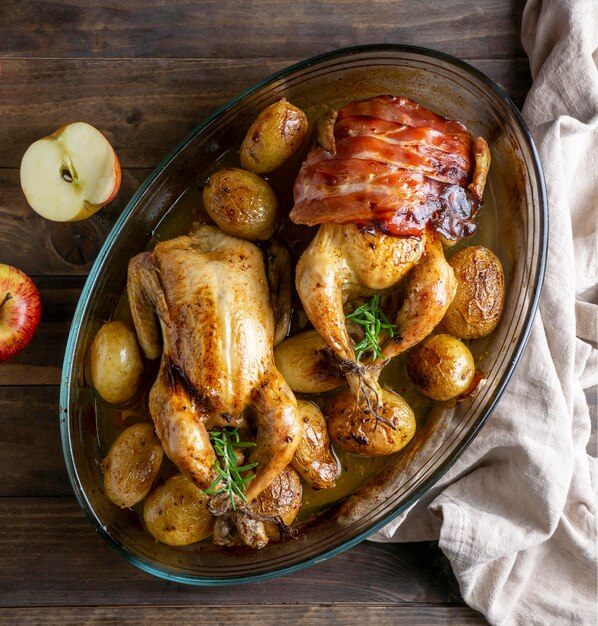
[0,0,531,624]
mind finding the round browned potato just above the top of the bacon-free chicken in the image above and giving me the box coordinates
[203,167,278,241]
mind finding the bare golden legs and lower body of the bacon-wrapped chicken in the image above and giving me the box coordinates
[296,224,456,409]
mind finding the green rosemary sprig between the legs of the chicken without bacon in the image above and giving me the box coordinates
[205,428,257,511]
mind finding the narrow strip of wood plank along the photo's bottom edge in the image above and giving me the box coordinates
[0,600,488,626]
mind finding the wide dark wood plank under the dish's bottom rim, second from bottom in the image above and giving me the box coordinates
[0,497,459,607]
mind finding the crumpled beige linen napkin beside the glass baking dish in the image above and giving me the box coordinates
[372,0,598,626]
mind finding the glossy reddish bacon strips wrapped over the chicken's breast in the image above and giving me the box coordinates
[290,96,479,239]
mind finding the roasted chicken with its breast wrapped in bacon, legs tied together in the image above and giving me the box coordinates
[290,96,490,413]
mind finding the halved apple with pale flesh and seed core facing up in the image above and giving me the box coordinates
[21,122,121,222]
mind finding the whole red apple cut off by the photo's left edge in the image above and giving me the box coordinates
[0,263,41,361]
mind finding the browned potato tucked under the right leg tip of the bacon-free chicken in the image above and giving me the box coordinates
[247,465,302,541]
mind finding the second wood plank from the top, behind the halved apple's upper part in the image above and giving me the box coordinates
[0,57,530,168]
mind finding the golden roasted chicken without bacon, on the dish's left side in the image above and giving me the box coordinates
[127,224,302,516]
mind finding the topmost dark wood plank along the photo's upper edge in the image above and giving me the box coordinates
[0,0,525,59]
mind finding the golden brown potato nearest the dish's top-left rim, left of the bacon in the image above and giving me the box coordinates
[240,98,308,174]
